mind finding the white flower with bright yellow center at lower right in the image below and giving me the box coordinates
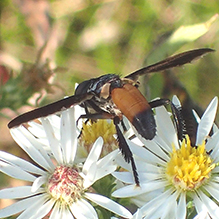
[112,97,219,219]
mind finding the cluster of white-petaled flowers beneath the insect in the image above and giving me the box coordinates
[0,97,219,219]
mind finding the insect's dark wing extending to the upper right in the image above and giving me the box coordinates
[125,48,215,81]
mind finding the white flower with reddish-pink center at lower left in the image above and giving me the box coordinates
[0,108,132,219]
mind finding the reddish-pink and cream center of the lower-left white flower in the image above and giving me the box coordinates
[47,166,83,205]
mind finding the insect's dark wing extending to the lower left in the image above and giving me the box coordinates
[8,93,93,128]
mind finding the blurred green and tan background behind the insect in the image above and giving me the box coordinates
[0,0,219,216]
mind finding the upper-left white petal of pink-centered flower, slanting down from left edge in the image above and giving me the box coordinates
[0,151,45,175]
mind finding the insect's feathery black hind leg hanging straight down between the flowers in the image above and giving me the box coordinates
[113,117,140,186]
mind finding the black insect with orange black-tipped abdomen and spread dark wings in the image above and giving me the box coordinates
[8,48,214,185]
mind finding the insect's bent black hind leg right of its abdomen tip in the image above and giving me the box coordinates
[149,99,186,140]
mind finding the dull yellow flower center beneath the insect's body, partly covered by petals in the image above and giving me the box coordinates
[79,119,118,156]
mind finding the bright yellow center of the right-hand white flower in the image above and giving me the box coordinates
[166,136,215,190]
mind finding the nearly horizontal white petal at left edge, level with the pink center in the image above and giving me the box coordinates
[0,186,43,199]
